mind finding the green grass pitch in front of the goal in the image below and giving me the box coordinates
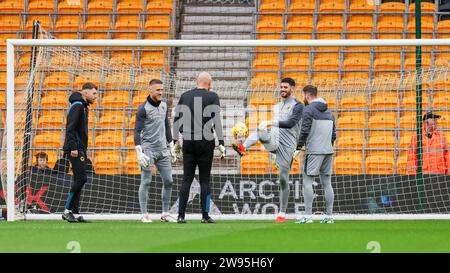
[0,220,450,253]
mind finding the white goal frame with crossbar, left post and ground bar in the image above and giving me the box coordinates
[5,39,450,221]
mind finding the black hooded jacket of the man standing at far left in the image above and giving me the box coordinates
[63,92,89,153]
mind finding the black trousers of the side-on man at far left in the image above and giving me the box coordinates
[66,151,87,211]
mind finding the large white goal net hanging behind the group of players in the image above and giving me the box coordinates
[0,33,450,219]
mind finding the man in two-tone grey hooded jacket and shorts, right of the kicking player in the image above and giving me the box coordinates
[297,85,336,224]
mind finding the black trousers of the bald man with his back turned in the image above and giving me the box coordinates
[178,140,215,217]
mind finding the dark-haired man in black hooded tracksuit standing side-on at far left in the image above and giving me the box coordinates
[62,82,97,223]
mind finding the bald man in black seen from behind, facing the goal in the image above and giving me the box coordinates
[173,72,225,223]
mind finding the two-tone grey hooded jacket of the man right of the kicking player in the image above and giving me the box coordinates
[298,98,336,154]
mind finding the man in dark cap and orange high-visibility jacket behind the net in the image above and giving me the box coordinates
[407,112,450,174]
